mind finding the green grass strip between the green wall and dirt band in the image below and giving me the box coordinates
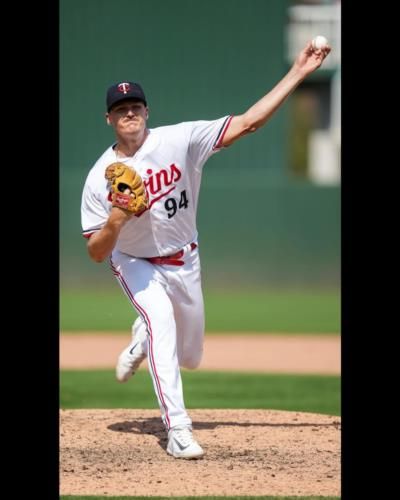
[60,288,340,333]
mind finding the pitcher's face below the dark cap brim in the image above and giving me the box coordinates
[107,100,148,134]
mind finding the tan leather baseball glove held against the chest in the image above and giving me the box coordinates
[105,162,149,215]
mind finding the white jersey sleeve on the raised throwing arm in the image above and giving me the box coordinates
[189,115,233,171]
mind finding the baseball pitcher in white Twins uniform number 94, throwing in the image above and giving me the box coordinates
[81,42,331,458]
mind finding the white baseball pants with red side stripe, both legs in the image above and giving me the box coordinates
[110,246,204,430]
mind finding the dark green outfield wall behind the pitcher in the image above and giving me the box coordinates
[60,0,340,288]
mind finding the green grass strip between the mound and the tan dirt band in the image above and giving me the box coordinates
[60,370,340,415]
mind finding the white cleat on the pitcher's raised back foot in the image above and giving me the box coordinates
[115,316,147,382]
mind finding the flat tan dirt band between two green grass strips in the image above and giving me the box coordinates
[60,333,340,375]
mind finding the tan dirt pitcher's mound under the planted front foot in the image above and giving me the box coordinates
[60,409,340,496]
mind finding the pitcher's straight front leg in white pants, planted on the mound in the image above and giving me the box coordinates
[112,252,192,429]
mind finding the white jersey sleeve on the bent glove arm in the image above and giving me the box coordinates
[81,177,109,238]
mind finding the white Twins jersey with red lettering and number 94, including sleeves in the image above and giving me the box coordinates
[81,115,232,257]
